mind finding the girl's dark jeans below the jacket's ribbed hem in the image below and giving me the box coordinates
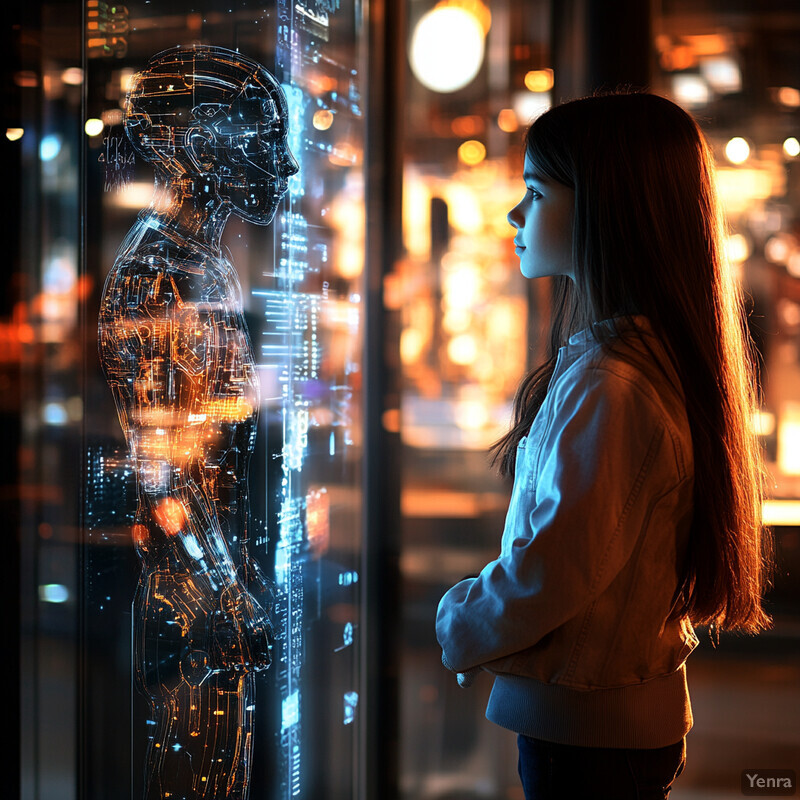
[517,735,686,800]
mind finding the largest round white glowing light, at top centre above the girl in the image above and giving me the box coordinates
[409,6,484,92]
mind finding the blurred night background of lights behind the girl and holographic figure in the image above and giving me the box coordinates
[6,0,800,800]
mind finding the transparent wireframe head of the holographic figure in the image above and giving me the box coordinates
[125,45,298,225]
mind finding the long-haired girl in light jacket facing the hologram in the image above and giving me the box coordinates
[436,93,771,800]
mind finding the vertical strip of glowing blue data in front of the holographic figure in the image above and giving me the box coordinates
[268,0,364,800]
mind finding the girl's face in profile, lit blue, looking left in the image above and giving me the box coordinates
[508,154,575,280]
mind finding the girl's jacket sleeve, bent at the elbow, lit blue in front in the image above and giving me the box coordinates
[436,368,674,672]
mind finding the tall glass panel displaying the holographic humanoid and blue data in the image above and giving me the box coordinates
[14,0,367,800]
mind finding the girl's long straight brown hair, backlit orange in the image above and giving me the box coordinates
[492,92,773,633]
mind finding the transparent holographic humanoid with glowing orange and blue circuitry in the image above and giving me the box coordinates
[99,46,298,800]
